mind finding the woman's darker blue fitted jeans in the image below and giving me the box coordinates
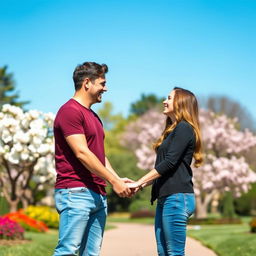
[155,193,195,256]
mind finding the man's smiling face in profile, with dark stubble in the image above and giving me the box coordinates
[89,76,107,103]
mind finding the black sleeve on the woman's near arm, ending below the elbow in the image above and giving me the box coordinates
[155,122,194,175]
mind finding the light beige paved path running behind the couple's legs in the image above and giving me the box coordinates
[101,223,217,256]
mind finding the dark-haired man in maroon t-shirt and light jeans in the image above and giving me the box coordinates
[54,62,131,256]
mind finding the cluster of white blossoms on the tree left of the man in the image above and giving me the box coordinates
[0,104,55,200]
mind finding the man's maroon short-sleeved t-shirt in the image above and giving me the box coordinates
[54,99,106,195]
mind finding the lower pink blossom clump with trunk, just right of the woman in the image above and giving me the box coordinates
[193,154,256,218]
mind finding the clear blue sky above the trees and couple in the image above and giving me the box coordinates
[0,0,256,123]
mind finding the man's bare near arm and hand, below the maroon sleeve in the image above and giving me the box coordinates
[66,134,131,197]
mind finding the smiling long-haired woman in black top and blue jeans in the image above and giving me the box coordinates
[131,87,203,256]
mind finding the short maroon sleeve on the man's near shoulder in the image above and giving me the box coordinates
[59,108,84,137]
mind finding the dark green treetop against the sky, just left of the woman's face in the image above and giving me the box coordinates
[130,94,164,116]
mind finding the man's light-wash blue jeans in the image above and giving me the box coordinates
[54,187,107,256]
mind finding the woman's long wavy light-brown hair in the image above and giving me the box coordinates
[153,87,203,167]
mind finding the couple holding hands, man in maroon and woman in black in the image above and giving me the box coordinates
[54,62,203,256]
